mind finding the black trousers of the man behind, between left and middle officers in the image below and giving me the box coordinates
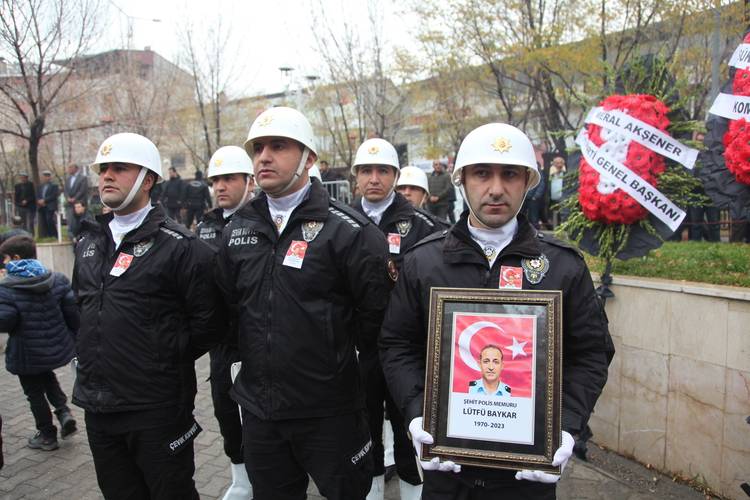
[209,344,244,464]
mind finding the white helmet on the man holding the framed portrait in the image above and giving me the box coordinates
[453,123,540,191]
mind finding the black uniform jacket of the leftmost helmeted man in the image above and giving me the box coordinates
[73,206,225,413]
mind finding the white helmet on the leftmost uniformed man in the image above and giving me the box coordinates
[91,132,164,182]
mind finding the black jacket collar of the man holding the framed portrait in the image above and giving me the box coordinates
[443,210,542,267]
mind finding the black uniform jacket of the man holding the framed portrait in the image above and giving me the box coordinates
[380,212,614,434]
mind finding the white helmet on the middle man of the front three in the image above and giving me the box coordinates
[245,106,317,156]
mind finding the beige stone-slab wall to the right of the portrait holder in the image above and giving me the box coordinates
[590,277,750,499]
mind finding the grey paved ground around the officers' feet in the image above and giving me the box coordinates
[0,348,705,500]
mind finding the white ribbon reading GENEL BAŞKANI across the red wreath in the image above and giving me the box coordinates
[576,130,686,231]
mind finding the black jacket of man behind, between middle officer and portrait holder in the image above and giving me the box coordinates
[354,193,448,267]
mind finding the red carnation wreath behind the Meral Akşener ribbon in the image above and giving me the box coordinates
[578,93,672,224]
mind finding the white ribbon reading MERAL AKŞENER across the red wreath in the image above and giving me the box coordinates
[586,107,698,168]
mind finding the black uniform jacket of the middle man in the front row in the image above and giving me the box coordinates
[219,179,392,420]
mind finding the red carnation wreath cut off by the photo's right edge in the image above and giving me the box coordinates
[724,34,750,185]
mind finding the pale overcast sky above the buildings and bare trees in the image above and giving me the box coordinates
[97,0,418,95]
